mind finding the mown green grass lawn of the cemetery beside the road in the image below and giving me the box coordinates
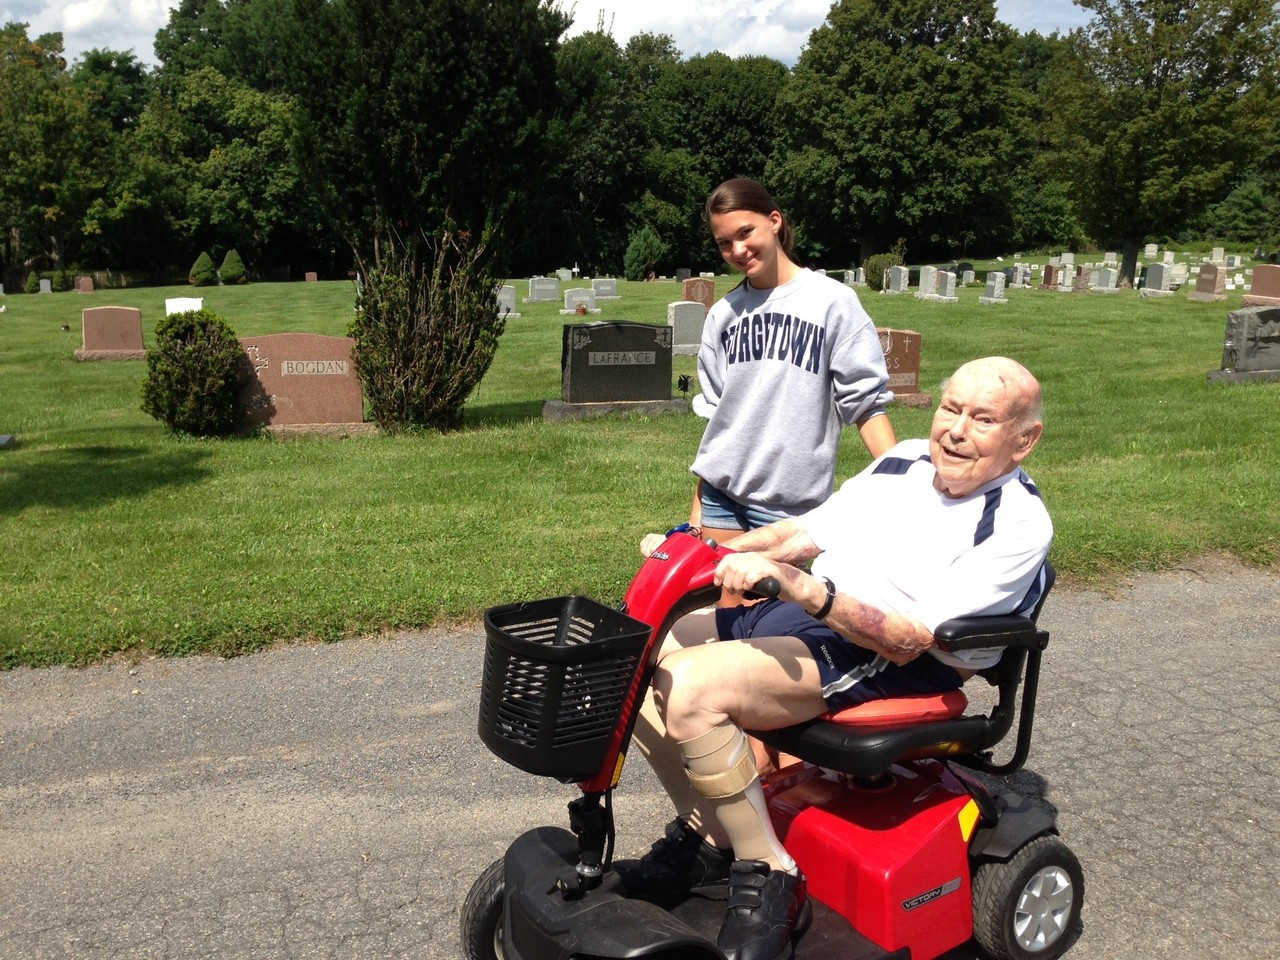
[0,274,1280,667]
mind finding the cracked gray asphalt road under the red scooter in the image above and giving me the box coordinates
[0,558,1280,960]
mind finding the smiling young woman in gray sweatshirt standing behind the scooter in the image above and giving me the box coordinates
[690,178,896,543]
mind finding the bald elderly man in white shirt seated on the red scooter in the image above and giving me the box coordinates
[618,357,1053,960]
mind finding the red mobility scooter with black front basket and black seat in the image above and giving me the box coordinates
[461,531,1084,960]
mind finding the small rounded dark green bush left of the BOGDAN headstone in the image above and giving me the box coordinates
[142,310,246,436]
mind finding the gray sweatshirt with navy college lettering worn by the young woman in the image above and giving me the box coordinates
[690,270,893,517]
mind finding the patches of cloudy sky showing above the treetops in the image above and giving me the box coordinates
[0,0,1088,65]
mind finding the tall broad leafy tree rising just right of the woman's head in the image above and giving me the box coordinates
[768,0,1016,262]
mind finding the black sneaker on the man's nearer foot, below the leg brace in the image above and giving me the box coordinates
[716,860,813,960]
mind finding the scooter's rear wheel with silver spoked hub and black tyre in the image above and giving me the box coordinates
[973,836,1084,960]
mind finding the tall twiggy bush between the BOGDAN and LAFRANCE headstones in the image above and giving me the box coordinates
[351,232,506,431]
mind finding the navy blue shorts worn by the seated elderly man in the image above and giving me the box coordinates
[716,600,964,710]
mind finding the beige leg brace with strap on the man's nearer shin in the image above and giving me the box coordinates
[680,721,795,870]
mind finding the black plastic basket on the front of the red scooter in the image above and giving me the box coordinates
[480,596,650,783]
